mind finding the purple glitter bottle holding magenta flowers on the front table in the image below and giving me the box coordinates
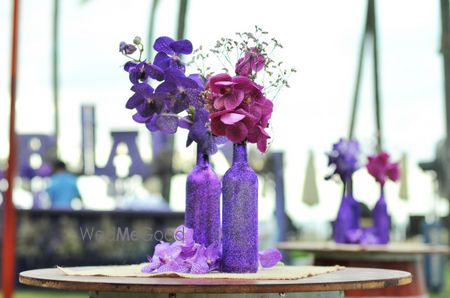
[222,142,258,273]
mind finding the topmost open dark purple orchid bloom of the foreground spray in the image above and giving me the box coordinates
[153,36,192,72]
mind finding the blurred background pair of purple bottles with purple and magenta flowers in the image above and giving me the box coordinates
[326,139,400,244]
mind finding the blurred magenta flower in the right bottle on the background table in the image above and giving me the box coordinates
[367,151,400,186]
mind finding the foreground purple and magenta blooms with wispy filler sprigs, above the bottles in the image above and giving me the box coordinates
[119,27,295,154]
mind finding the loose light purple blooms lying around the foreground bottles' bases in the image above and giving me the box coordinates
[141,225,282,274]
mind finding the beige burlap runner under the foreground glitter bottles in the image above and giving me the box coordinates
[58,264,344,280]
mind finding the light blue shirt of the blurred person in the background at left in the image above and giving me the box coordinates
[47,172,81,209]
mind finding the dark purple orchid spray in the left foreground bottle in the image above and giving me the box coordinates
[120,36,226,154]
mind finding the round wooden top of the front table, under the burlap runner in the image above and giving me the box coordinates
[19,268,412,293]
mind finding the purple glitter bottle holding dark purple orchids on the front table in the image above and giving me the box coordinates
[185,146,220,246]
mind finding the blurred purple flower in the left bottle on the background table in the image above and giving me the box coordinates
[326,139,360,182]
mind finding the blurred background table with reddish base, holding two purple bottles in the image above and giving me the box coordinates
[277,242,449,298]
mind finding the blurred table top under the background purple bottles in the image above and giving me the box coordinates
[277,241,450,255]
